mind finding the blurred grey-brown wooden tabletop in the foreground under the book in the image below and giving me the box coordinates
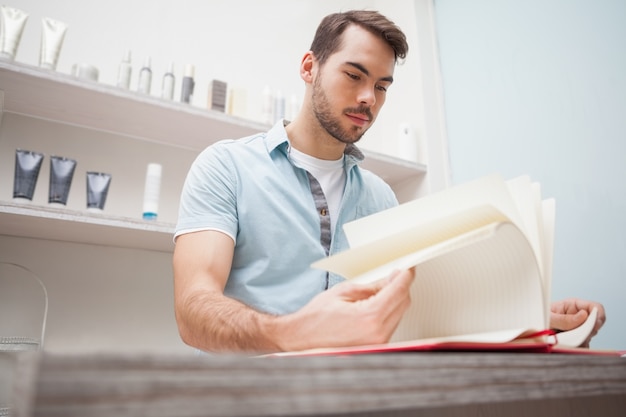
[7,353,626,417]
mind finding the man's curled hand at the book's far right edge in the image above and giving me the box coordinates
[550,298,606,348]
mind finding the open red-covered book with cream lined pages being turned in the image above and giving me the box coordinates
[286,175,595,353]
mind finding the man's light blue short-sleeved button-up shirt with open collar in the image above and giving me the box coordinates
[175,121,398,314]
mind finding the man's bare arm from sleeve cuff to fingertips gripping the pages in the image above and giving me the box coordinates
[173,231,414,352]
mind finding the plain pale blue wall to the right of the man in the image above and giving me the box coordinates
[435,0,626,349]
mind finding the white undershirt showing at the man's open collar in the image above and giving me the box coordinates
[289,147,346,234]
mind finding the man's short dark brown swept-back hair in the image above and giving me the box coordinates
[311,10,409,65]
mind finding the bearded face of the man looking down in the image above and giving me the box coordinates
[312,25,395,144]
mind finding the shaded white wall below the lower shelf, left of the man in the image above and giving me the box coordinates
[0,236,184,353]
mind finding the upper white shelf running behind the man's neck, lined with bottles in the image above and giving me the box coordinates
[0,61,426,185]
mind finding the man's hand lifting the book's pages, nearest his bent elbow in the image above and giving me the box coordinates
[277,269,415,350]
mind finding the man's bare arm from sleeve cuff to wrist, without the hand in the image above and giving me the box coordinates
[173,231,276,351]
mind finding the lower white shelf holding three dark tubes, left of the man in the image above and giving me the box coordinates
[0,202,174,252]
